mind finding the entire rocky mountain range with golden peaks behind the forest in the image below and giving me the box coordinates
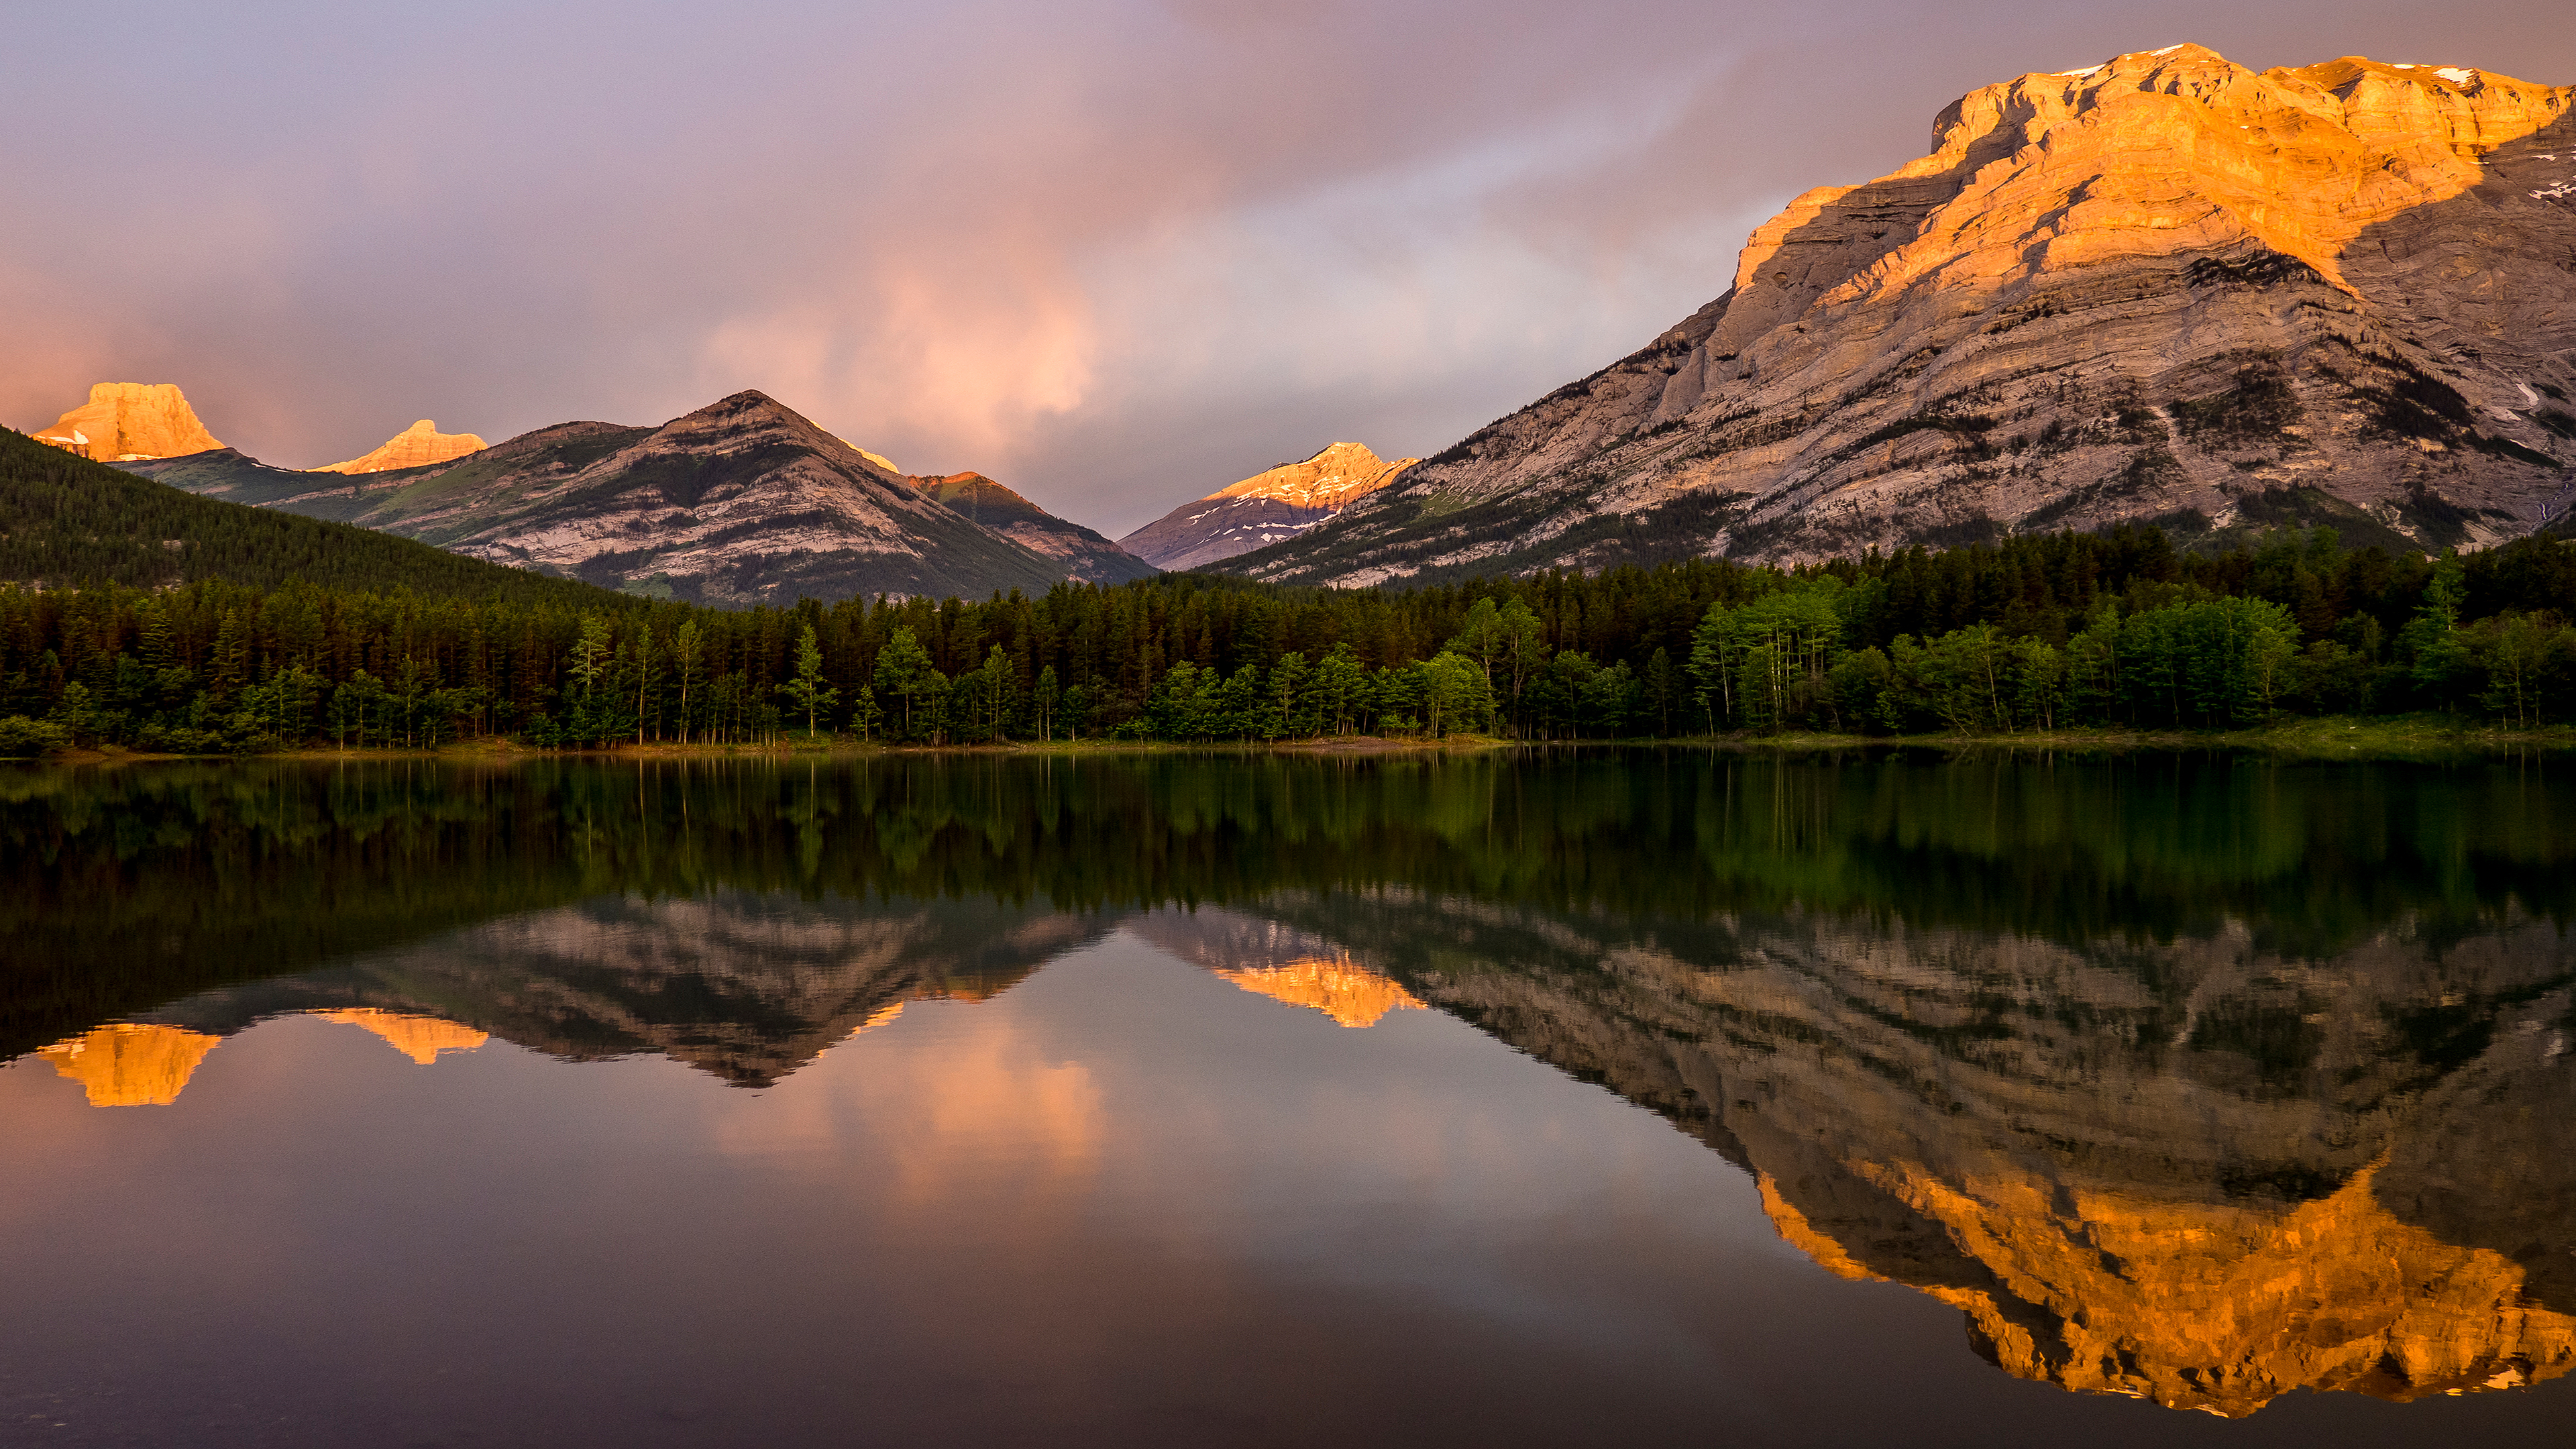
[20,44,2576,606]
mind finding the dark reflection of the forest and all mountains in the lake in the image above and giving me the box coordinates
[0,753,2576,1415]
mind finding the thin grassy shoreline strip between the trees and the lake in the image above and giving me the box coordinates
[25,714,2576,765]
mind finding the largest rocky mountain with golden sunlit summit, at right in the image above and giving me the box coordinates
[1221,46,2576,585]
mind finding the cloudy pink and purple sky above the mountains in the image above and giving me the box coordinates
[0,0,2576,536]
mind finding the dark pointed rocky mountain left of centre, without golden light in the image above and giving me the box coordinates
[131,392,1097,606]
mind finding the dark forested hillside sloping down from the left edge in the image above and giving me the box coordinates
[0,428,636,608]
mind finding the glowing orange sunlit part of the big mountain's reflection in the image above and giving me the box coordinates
[1760,1163,2576,1418]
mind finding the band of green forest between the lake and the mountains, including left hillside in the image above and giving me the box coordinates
[0,423,2576,755]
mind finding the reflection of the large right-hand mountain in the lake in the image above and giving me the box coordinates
[1241,900,2576,1415]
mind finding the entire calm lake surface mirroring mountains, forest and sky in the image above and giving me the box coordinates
[0,753,2576,1446]
